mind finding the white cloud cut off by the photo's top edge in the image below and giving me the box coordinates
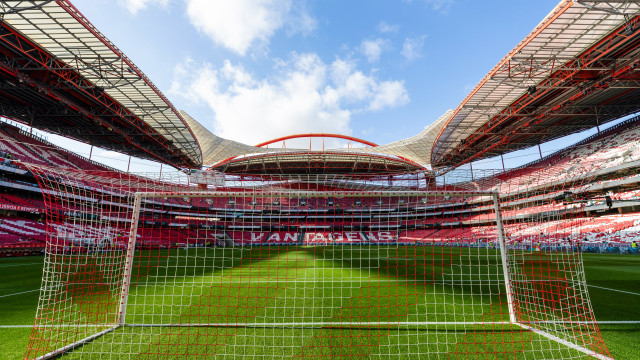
[186,0,316,55]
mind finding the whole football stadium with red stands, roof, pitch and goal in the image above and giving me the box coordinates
[0,0,640,359]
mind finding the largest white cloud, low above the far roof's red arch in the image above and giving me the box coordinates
[170,53,409,144]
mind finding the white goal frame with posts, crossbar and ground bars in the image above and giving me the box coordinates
[36,190,612,360]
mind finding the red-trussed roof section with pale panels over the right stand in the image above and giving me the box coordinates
[431,0,640,167]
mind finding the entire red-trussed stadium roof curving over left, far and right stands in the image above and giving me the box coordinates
[0,0,640,174]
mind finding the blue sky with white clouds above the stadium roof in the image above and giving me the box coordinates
[32,0,628,173]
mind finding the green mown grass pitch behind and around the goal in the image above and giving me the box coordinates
[0,247,640,359]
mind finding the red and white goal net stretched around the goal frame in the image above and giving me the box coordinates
[25,168,608,359]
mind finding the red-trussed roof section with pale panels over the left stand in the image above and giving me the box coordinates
[0,0,202,167]
